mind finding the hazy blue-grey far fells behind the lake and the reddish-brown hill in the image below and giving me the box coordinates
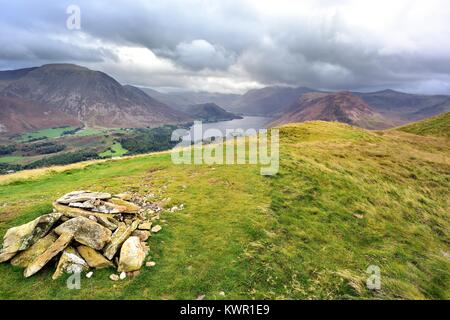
[144,86,450,125]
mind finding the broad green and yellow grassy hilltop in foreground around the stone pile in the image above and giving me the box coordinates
[0,122,450,299]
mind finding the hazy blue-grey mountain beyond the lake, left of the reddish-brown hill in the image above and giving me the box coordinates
[227,86,317,117]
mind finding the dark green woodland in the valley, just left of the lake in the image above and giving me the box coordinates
[119,125,177,154]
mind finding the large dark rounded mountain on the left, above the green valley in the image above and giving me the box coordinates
[0,64,189,131]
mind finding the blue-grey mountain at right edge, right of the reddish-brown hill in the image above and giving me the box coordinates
[353,90,450,123]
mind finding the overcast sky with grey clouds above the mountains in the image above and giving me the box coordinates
[0,0,450,94]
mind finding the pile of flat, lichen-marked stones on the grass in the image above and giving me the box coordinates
[0,190,161,279]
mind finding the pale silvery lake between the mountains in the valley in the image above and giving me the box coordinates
[183,117,272,141]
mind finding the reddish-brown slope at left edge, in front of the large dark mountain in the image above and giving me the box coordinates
[0,97,81,133]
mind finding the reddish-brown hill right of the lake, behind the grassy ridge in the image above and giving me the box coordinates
[273,92,393,129]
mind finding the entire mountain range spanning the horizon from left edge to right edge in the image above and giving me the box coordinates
[0,64,450,133]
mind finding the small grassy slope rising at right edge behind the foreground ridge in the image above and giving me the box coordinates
[398,112,450,138]
